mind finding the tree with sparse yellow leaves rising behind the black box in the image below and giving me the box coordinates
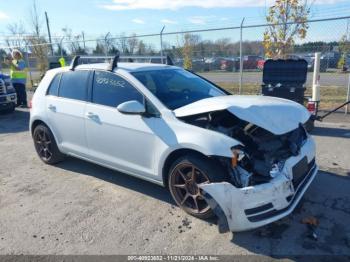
[263,0,310,58]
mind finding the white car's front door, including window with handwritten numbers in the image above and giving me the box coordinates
[85,71,160,177]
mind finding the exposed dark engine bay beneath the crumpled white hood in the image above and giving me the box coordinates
[181,110,307,188]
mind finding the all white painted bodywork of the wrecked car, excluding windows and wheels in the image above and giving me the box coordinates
[30,63,317,231]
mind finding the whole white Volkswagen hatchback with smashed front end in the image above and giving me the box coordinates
[30,57,317,231]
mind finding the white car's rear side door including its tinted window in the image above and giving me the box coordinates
[46,70,90,156]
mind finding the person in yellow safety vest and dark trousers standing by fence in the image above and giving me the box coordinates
[8,49,28,108]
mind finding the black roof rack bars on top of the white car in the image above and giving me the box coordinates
[69,53,174,71]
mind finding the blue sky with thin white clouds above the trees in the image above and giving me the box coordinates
[0,0,350,47]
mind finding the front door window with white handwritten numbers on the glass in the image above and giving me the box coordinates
[92,71,143,107]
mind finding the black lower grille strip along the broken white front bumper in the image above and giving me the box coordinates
[245,159,316,222]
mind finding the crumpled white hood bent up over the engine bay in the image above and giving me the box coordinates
[174,95,310,135]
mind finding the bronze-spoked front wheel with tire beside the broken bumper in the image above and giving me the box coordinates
[169,162,211,215]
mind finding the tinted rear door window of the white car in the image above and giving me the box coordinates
[59,71,89,101]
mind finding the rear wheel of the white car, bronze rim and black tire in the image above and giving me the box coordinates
[33,124,65,165]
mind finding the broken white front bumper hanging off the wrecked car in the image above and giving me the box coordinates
[201,137,318,232]
